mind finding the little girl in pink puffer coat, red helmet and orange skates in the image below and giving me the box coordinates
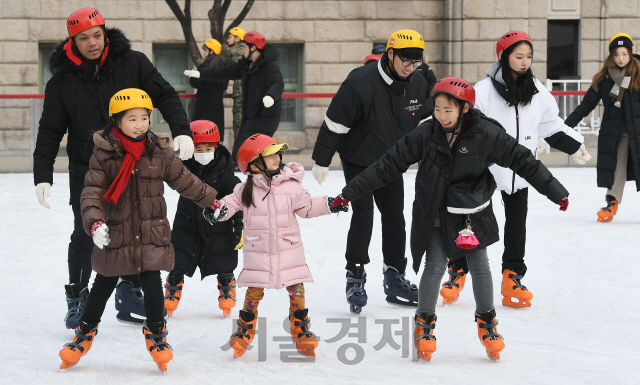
[204,134,348,357]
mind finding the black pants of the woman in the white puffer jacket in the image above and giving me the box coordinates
[451,188,529,275]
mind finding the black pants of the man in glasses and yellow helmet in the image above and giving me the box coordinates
[342,161,407,273]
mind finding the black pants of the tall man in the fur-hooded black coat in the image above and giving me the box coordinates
[67,173,140,287]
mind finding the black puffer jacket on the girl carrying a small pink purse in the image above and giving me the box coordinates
[342,110,569,273]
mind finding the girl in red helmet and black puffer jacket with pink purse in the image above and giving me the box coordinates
[336,77,569,360]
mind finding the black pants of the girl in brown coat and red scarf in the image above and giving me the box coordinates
[82,271,164,324]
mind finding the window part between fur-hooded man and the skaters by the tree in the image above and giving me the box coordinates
[151,44,193,132]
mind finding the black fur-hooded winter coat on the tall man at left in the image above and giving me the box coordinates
[33,28,191,184]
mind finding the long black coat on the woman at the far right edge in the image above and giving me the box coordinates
[564,75,640,191]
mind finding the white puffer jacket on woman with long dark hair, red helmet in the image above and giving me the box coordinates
[474,62,584,194]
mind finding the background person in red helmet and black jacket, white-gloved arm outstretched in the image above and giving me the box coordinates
[184,31,284,160]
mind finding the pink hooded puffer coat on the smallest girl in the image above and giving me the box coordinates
[220,163,330,289]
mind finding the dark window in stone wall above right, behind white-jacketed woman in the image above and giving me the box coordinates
[547,20,580,79]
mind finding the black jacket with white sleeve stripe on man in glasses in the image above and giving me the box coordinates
[312,55,433,167]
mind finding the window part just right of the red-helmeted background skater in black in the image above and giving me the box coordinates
[274,44,304,131]
